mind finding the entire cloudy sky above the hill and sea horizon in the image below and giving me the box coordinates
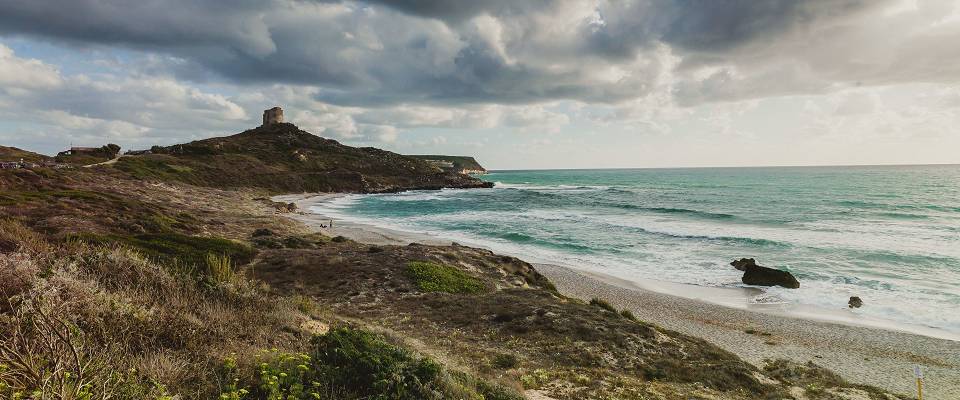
[0,0,960,168]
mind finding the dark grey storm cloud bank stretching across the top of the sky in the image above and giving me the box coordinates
[0,0,953,106]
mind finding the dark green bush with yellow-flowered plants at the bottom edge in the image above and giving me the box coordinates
[220,326,522,400]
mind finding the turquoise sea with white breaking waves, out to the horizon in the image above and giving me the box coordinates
[317,165,960,332]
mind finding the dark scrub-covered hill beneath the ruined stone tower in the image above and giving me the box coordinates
[117,124,489,193]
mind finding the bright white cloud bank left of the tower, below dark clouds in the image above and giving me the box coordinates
[0,45,250,151]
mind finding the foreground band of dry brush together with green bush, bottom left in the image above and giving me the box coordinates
[0,221,519,400]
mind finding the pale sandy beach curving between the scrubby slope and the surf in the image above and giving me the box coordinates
[274,194,960,399]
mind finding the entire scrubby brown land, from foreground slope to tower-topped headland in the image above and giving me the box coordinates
[0,123,944,400]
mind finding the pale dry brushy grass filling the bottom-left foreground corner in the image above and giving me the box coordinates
[0,221,309,399]
